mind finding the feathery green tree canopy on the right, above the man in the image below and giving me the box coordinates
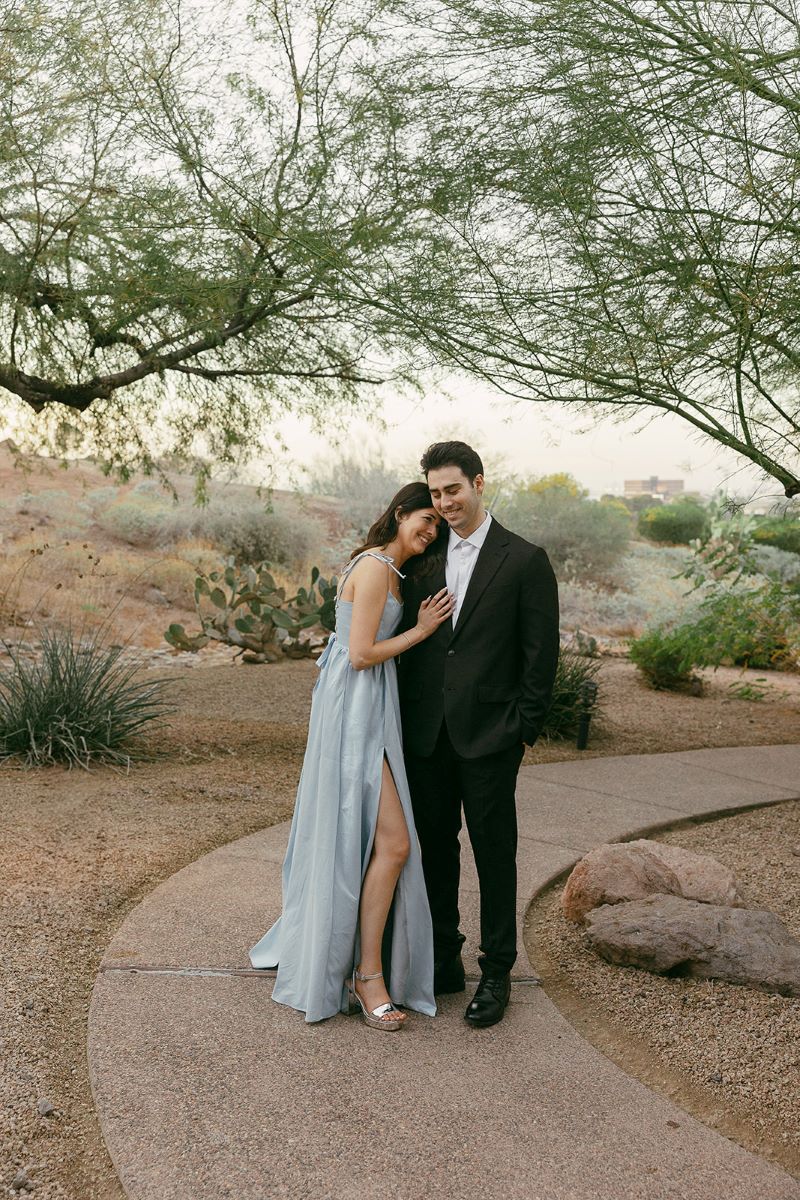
[371,0,800,497]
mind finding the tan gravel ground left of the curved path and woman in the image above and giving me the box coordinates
[0,662,315,1200]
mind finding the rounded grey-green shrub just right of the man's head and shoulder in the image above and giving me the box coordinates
[495,486,631,580]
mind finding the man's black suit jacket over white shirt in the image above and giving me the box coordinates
[398,520,559,758]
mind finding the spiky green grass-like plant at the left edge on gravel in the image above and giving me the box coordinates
[0,630,169,768]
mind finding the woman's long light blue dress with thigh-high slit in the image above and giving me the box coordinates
[249,551,435,1021]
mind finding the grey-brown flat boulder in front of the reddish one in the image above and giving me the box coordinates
[584,895,800,996]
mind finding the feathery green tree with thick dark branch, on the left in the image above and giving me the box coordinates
[0,0,412,477]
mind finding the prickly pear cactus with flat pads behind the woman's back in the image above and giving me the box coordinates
[164,557,336,662]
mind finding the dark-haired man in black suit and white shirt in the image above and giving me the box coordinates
[399,442,559,1027]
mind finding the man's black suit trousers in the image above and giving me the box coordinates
[405,721,524,974]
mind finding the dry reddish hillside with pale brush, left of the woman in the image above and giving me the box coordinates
[0,443,347,665]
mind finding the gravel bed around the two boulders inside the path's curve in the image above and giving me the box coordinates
[528,800,800,1172]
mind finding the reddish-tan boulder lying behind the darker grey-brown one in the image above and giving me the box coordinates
[561,838,744,920]
